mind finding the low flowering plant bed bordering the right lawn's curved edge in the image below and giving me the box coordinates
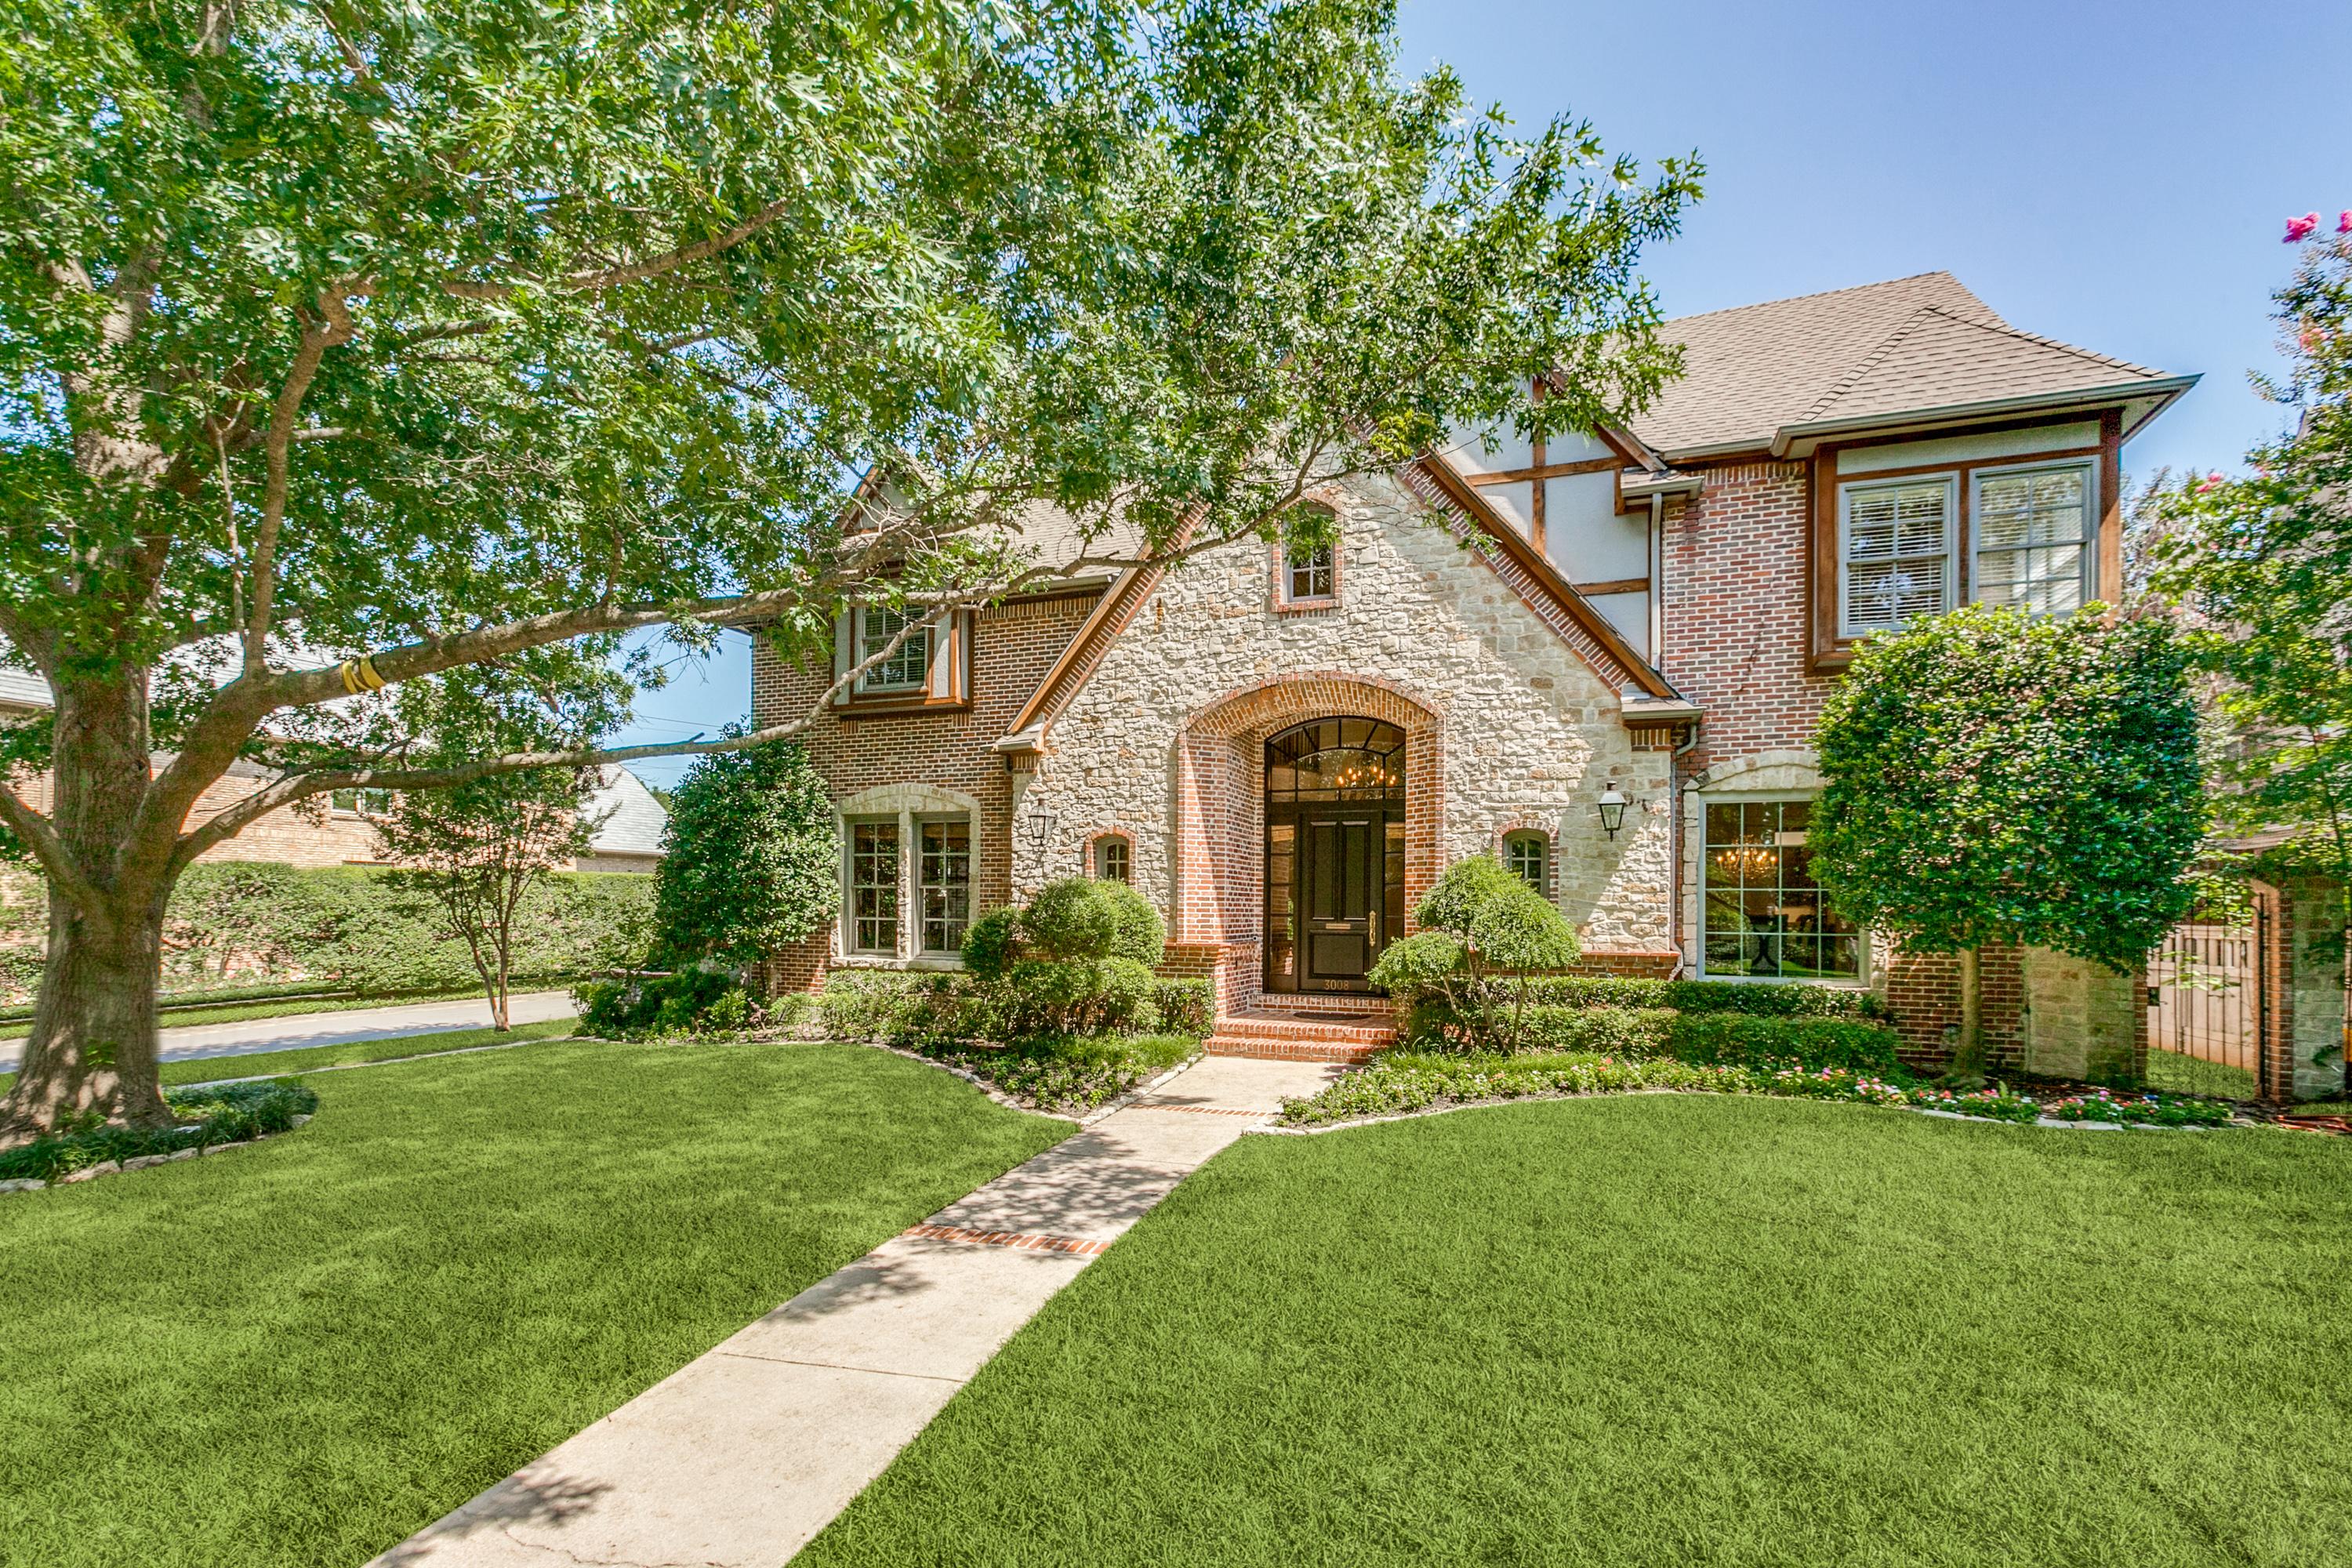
[1282,1051,2232,1126]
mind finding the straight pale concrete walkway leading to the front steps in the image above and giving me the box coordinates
[369,1055,1334,1568]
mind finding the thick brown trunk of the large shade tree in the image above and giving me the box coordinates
[0,670,176,1142]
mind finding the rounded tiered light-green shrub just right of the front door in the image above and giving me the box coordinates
[1369,855,1581,1051]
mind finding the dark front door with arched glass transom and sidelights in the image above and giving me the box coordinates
[1265,717,1404,992]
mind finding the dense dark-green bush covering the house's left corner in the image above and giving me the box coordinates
[654,741,842,964]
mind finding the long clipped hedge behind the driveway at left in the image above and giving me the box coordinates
[0,860,654,999]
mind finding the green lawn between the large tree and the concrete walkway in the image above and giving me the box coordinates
[0,1041,1070,1568]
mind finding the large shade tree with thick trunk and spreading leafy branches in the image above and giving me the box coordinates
[0,0,1698,1138]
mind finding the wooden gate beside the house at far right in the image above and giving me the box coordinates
[2147,907,2272,1100]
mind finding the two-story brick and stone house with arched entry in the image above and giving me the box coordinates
[753,273,2194,1072]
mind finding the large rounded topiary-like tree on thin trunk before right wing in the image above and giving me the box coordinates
[1809,604,2206,1079]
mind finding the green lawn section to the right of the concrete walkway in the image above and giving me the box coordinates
[793,1095,2352,1568]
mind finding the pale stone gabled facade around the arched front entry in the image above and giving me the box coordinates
[1011,477,1672,996]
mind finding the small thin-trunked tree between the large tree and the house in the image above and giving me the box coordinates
[374,769,595,1029]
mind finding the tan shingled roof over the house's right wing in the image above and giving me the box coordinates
[1632,273,2192,459]
